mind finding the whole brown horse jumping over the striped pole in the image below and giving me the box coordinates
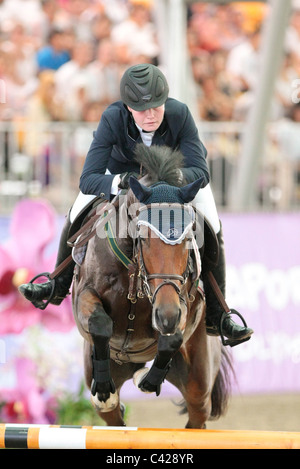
[72,144,231,429]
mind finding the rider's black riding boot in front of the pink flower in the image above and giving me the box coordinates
[19,212,75,309]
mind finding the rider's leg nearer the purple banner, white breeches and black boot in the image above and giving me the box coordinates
[193,185,253,340]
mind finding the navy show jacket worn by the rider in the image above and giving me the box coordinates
[79,98,209,200]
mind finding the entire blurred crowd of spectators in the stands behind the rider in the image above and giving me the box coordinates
[0,0,300,208]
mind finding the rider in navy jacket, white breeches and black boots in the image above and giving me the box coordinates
[19,63,253,343]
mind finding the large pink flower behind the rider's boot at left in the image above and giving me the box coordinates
[0,199,75,335]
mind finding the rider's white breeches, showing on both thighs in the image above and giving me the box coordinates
[70,184,220,234]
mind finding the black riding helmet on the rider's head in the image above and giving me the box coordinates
[120,63,169,111]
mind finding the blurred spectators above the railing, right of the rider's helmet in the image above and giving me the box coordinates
[188,2,300,121]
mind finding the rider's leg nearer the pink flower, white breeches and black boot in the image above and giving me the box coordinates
[19,192,95,309]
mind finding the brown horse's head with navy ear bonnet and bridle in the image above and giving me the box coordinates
[130,178,202,335]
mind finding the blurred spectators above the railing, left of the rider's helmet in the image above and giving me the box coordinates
[0,0,159,122]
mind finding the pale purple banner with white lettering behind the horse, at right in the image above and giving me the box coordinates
[221,213,300,393]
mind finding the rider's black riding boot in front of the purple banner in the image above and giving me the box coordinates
[203,227,253,345]
